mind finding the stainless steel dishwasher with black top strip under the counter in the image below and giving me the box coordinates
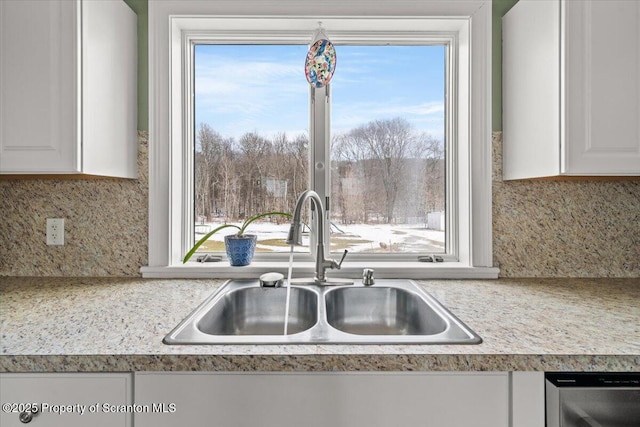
[545,372,640,427]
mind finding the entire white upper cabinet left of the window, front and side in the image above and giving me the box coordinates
[0,0,137,178]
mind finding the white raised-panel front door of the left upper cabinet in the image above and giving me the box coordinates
[0,0,79,173]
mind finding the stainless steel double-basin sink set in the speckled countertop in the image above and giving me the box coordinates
[164,279,482,344]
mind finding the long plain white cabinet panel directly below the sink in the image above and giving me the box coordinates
[135,372,509,427]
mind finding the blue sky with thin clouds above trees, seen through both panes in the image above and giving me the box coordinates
[195,45,445,139]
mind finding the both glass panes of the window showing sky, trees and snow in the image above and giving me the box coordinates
[192,43,454,256]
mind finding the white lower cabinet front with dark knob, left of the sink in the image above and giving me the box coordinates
[0,374,132,427]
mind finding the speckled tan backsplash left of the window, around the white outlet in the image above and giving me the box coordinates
[0,132,149,276]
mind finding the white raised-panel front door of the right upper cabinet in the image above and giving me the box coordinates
[561,0,640,175]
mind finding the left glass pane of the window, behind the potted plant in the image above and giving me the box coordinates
[194,45,309,252]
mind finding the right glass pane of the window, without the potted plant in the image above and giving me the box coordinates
[331,45,446,253]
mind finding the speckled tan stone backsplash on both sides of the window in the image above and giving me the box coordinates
[0,132,640,277]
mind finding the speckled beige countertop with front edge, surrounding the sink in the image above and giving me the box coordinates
[0,277,640,372]
